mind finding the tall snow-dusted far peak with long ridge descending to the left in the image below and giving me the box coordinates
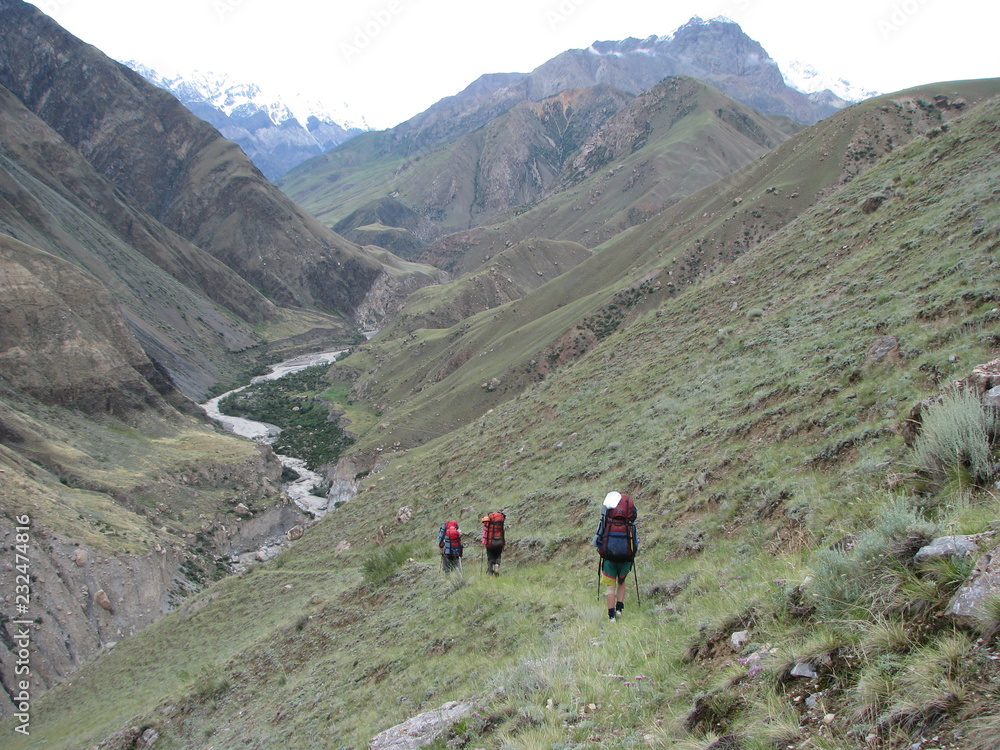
[278,19,843,253]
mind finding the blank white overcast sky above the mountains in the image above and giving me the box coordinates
[21,0,1000,128]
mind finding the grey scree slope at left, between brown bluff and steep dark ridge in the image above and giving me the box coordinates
[0,81,274,398]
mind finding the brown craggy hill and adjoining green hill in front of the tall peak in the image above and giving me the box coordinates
[283,77,801,280]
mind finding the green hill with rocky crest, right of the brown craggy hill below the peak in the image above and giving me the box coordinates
[417,76,800,270]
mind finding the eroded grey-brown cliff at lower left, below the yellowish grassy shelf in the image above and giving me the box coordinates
[0,446,292,715]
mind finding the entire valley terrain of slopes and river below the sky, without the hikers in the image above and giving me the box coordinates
[0,0,1000,750]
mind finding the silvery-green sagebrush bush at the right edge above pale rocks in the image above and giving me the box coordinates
[913,389,996,490]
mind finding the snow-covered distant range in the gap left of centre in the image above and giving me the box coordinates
[125,60,370,180]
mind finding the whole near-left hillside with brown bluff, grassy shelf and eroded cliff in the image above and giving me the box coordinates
[0,235,300,715]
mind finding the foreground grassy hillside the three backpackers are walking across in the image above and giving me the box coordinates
[7,88,1000,749]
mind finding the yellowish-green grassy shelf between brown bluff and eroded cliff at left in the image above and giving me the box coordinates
[0,396,278,554]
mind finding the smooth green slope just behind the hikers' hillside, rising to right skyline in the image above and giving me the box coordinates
[334,80,1000,456]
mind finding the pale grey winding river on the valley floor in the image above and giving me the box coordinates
[201,349,346,518]
